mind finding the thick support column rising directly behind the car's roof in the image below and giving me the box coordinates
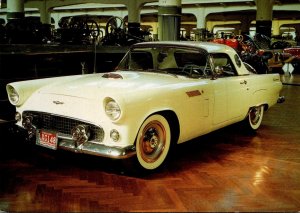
[158,0,181,41]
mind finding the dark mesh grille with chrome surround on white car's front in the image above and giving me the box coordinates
[22,111,104,142]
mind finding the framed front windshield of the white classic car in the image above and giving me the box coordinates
[118,46,209,77]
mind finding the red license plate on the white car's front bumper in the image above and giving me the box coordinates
[36,130,57,150]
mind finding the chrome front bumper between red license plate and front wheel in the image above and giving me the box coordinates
[58,139,136,159]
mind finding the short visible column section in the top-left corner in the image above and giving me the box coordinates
[6,0,25,22]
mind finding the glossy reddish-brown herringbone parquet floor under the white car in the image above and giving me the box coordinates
[0,75,300,212]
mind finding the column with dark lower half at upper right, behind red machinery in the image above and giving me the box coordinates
[255,0,274,37]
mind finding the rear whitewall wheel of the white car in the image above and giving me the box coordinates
[245,105,264,131]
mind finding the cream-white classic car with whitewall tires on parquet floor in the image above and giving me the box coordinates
[7,42,283,170]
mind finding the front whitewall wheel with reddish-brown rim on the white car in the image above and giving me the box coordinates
[136,114,171,170]
